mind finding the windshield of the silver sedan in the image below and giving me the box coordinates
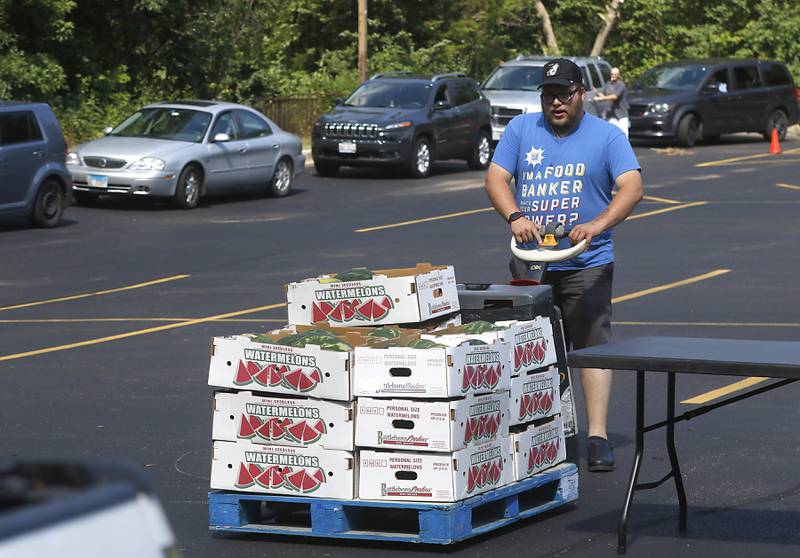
[109,107,211,142]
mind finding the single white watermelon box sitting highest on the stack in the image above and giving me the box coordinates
[286,264,459,326]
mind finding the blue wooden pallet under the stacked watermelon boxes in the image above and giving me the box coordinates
[208,463,578,544]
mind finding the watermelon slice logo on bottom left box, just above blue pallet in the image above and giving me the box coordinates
[235,451,325,494]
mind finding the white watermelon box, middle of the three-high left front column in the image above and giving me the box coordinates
[211,391,355,451]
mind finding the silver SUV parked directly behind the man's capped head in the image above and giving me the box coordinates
[481,56,611,142]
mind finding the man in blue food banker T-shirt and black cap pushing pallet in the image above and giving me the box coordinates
[485,58,643,471]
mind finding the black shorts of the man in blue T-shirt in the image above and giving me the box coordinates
[510,258,614,349]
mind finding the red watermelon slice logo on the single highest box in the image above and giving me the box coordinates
[311,286,394,323]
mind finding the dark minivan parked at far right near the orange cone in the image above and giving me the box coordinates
[628,59,800,147]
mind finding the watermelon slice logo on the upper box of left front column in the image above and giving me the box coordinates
[233,349,322,393]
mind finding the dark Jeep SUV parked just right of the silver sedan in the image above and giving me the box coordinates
[311,72,492,177]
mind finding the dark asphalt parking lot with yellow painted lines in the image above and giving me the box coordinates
[0,135,800,558]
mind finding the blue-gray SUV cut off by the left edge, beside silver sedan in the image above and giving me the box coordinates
[0,101,72,228]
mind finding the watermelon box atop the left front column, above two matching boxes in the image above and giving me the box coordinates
[208,335,353,401]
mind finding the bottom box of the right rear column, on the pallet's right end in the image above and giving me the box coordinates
[511,416,567,480]
